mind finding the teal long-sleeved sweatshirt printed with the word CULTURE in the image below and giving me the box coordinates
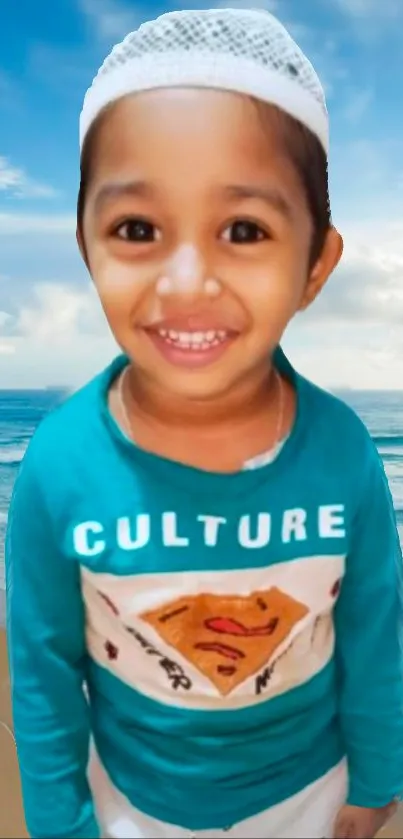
[6,351,403,839]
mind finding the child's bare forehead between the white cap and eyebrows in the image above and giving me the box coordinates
[96,89,290,171]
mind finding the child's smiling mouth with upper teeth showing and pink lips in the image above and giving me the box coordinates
[146,328,236,367]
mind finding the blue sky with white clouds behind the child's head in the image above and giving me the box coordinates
[0,0,403,389]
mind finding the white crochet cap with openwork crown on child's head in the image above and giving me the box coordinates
[80,8,329,153]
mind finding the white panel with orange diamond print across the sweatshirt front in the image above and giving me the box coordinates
[82,556,344,710]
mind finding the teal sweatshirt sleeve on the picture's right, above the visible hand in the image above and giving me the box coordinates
[335,441,403,807]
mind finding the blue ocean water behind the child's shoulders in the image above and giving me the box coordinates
[0,389,403,588]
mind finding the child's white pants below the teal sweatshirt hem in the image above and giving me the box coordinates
[89,755,347,839]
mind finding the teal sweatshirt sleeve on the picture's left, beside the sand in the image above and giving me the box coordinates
[6,438,100,839]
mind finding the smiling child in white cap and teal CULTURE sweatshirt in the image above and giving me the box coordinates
[7,9,403,839]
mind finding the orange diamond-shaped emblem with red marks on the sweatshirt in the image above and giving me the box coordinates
[140,588,309,696]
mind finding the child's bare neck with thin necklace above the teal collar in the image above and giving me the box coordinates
[109,365,295,472]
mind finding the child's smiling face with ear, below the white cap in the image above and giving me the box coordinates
[80,90,340,399]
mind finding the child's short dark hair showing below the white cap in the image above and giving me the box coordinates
[77,99,331,267]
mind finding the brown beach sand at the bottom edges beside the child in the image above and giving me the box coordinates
[0,600,403,839]
